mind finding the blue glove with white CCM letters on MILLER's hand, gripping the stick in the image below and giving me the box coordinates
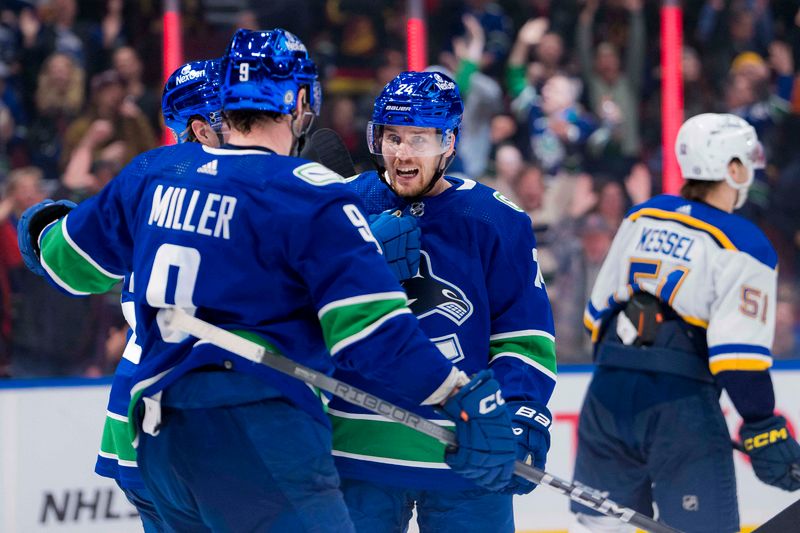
[443,370,517,491]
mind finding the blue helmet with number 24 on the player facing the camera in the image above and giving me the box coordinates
[367,72,464,155]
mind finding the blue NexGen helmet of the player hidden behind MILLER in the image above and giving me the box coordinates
[161,59,222,143]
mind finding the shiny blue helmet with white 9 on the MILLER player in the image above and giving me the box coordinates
[222,28,322,115]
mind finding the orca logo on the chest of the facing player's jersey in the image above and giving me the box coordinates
[403,250,473,326]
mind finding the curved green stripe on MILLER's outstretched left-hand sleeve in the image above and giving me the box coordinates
[41,218,122,294]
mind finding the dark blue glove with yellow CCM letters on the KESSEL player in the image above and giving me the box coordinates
[739,416,800,490]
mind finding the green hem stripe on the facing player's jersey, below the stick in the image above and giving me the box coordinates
[328,412,454,468]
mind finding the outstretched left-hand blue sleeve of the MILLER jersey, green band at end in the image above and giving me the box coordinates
[39,154,146,296]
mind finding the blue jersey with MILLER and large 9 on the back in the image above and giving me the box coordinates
[40,143,462,436]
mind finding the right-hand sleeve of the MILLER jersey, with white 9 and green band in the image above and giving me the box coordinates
[289,186,454,403]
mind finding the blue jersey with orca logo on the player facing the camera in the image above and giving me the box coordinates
[328,172,556,489]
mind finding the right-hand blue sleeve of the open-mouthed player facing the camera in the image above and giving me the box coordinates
[487,210,557,404]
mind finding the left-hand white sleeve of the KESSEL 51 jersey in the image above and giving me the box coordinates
[583,219,633,342]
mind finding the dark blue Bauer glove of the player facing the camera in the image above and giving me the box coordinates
[503,402,553,494]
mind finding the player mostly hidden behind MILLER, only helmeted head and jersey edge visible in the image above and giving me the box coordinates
[95,59,225,533]
